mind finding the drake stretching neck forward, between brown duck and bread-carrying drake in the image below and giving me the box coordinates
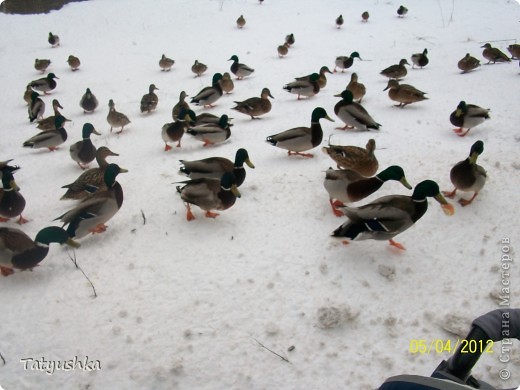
[323,165,412,217]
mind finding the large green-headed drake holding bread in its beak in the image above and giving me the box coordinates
[332,180,455,250]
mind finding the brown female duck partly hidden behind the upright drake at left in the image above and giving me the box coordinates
[60,146,119,200]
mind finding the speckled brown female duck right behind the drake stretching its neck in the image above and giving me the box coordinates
[321,138,379,177]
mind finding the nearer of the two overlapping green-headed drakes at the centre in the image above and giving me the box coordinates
[177,172,240,221]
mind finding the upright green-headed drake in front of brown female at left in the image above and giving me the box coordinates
[55,164,128,239]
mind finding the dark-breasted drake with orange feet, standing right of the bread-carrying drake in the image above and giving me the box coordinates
[443,140,487,207]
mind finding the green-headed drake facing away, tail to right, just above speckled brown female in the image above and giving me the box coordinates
[334,89,381,130]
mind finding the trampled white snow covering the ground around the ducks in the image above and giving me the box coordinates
[0,0,520,390]
